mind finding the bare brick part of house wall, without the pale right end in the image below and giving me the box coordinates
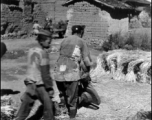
[67,2,109,47]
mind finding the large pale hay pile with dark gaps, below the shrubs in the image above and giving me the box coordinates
[90,50,151,84]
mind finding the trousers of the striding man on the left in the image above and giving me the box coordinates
[16,83,55,120]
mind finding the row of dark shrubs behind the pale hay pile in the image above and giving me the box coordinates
[100,32,151,51]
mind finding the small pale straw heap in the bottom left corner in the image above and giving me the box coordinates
[1,96,17,120]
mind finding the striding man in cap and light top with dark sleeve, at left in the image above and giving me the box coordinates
[15,30,55,120]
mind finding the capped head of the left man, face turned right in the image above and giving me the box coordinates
[36,30,52,49]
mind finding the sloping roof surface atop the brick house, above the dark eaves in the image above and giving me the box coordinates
[63,0,132,9]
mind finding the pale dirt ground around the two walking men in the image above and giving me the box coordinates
[1,38,151,120]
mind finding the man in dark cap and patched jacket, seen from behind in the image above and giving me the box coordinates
[54,25,100,118]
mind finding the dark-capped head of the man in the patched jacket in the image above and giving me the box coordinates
[72,25,85,37]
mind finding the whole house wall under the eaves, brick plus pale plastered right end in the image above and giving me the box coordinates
[66,2,129,48]
